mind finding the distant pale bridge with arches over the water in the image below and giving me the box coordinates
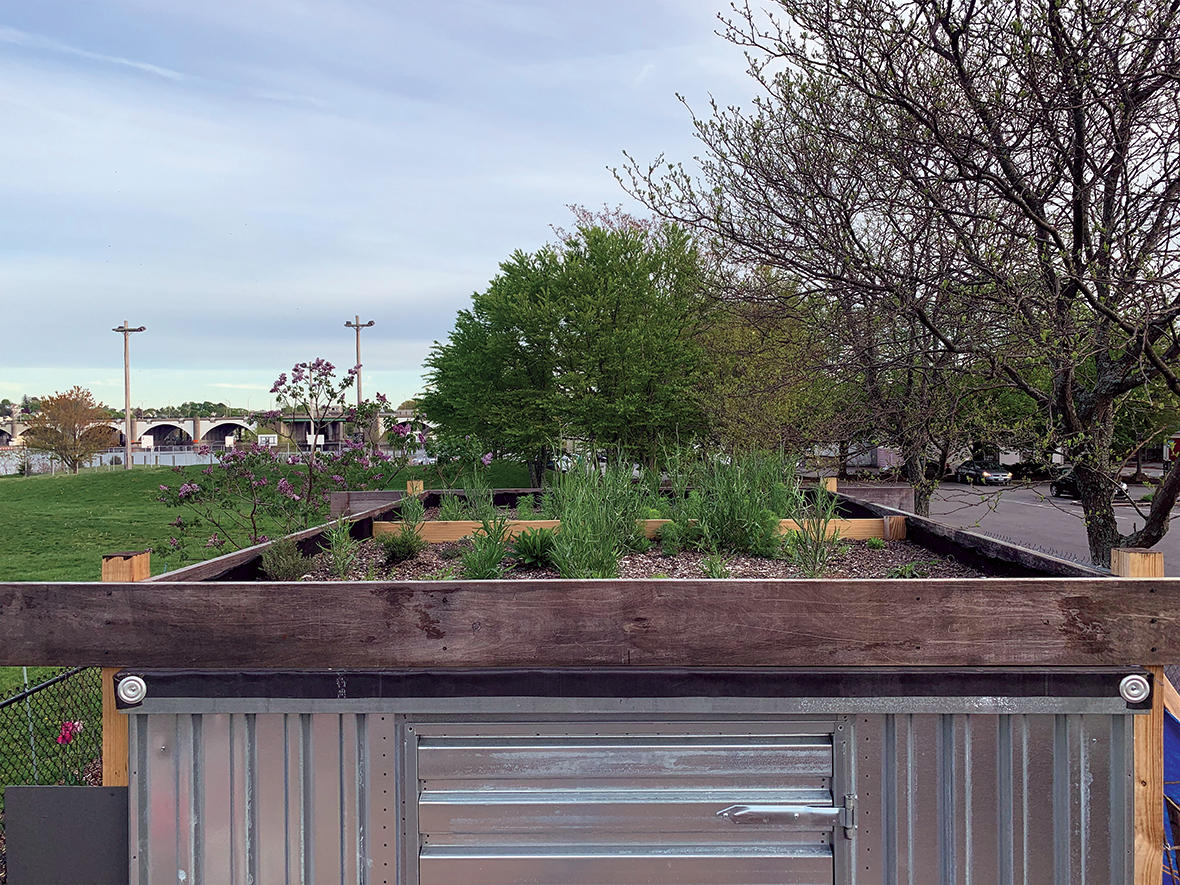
[0,409,415,447]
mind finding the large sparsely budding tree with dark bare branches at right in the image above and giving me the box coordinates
[631,0,1180,563]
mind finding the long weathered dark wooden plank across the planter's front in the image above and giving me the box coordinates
[0,578,1180,668]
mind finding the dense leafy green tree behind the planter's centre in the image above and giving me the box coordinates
[419,216,708,483]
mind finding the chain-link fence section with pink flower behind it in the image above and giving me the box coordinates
[0,667,103,885]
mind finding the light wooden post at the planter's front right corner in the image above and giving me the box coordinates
[1110,548,1166,885]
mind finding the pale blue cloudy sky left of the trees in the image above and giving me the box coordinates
[0,0,753,408]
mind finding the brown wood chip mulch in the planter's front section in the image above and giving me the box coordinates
[304,540,985,581]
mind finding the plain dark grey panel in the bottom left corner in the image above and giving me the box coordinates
[5,787,131,885]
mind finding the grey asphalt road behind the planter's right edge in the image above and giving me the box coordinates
[930,483,1180,577]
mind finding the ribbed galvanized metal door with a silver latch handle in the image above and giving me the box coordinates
[408,723,844,885]
